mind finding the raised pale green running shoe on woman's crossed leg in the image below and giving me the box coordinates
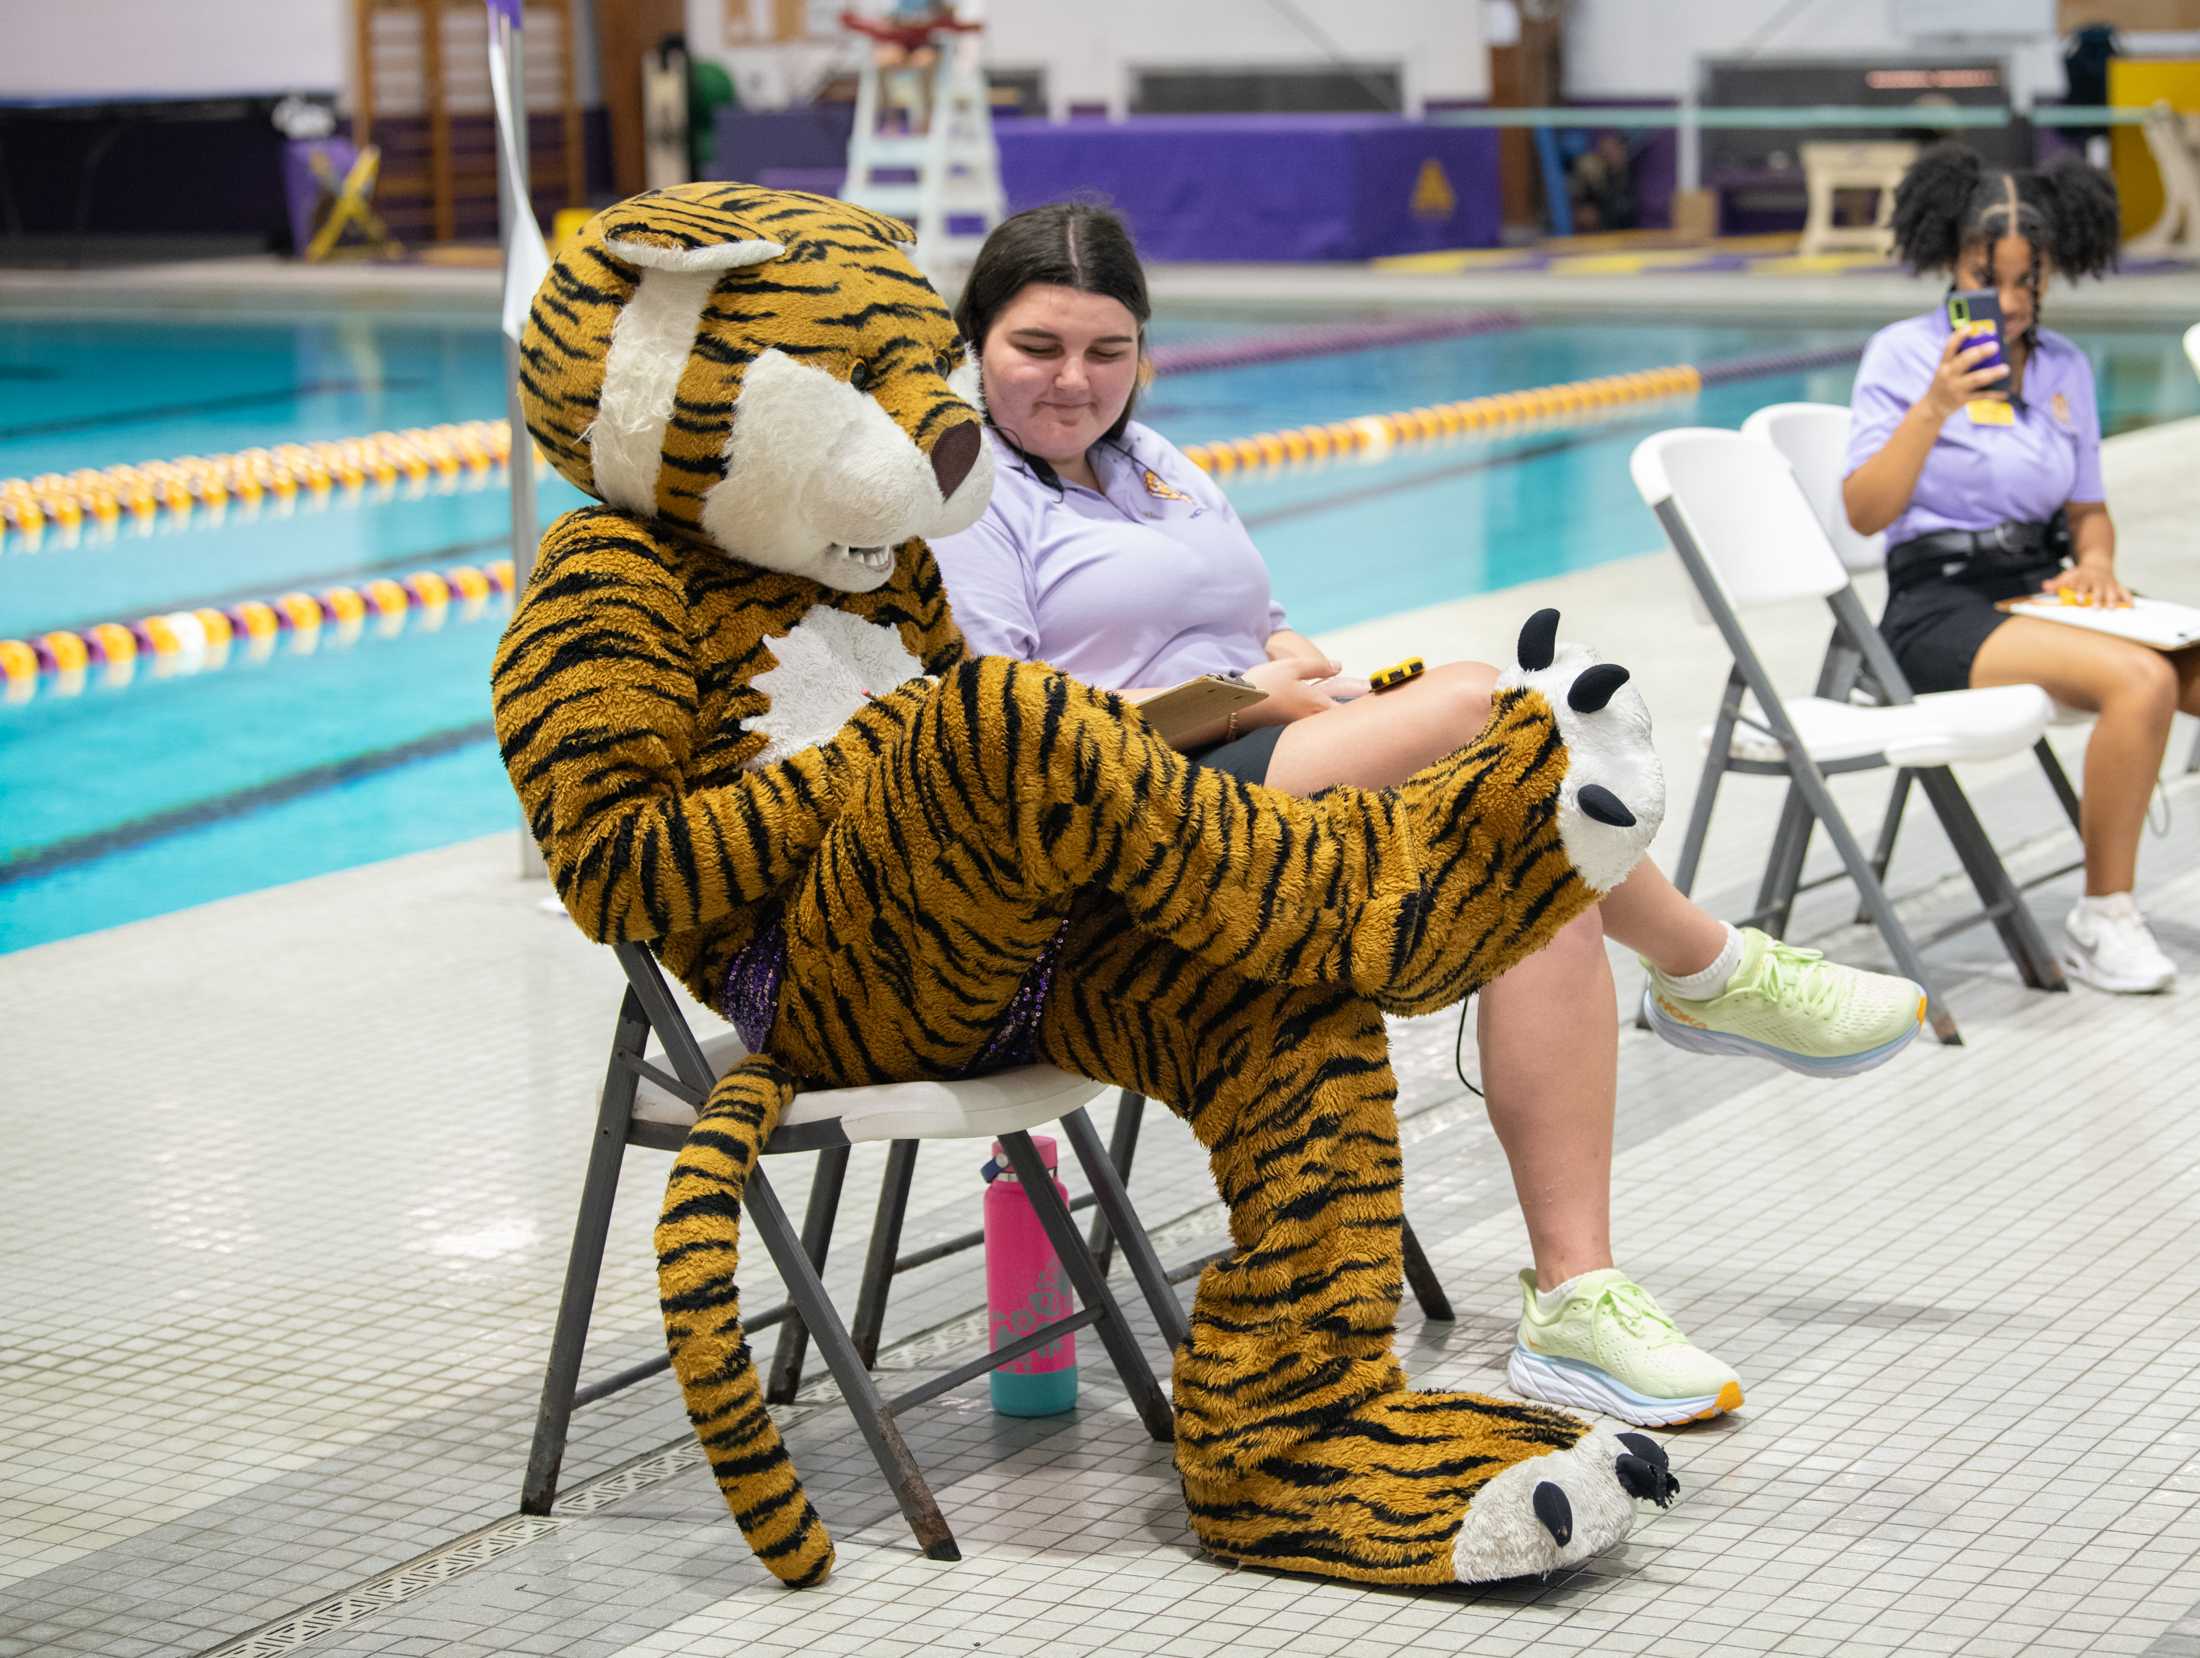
[1643,928,1925,1077]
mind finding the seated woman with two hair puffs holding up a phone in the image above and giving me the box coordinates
[1841,145,2200,992]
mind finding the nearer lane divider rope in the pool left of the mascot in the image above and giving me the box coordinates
[0,559,513,704]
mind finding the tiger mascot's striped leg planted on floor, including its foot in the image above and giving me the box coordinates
[1041,904,1676,1583]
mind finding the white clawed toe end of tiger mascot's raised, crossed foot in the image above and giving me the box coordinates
[1496,609,1665,893]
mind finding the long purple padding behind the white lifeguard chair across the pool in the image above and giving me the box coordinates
[717,108,1498,262]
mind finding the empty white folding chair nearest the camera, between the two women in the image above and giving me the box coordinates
[1630,427,2066,1042]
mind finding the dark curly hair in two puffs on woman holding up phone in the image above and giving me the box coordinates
[1894,143,2121,290]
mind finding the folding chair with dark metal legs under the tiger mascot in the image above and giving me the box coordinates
[519,943,1188,1559]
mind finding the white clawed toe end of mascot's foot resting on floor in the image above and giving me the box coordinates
[1452,1429,1681,1583]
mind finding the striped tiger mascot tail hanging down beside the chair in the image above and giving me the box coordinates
[658,1058,832,1588]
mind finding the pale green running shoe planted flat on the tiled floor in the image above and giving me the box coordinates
[1505,1267,1742,1427]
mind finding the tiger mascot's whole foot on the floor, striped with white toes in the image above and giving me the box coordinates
[1179,1392,1681,1583]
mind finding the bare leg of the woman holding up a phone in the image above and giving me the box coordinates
[1971,618,2200,897]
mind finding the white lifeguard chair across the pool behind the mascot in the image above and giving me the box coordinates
[840,4,1008,281]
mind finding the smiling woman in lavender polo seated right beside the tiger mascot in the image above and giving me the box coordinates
[933,202,1923,1425]
